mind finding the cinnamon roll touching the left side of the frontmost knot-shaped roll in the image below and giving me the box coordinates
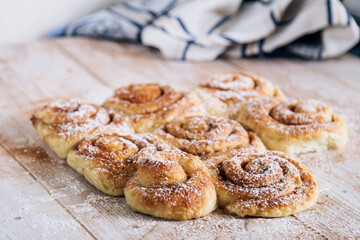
[66,133,165,196]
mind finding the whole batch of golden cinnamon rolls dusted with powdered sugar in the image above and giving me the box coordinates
[31,72,347,220]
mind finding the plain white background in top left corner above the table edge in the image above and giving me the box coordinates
[0,0,124,46]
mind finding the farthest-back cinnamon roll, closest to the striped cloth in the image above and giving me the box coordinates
[196,72,284,119]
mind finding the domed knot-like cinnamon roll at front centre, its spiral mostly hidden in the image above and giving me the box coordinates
[124,150,217,220]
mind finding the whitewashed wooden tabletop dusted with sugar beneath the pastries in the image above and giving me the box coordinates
[0,39,360,239]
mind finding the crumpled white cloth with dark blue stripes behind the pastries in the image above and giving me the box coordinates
[50,0,359,61]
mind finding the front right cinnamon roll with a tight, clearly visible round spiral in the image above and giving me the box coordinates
[205,149,318,217]
